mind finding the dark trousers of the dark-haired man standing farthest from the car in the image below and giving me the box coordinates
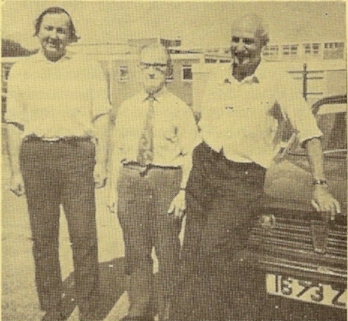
[20,139,98,313]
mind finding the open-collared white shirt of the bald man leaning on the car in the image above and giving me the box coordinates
[199,63,322,168]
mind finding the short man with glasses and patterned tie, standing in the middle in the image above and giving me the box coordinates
[110,45,200,321]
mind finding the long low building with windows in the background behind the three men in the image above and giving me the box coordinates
[2,37,347,120]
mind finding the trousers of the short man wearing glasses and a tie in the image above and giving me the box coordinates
[117,167,182,316]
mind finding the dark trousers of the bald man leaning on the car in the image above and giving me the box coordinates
[171,142,266,321]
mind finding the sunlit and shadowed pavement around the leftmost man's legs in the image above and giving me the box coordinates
[1,142,135,321]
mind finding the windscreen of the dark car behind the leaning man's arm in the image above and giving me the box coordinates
[289,104,347,157]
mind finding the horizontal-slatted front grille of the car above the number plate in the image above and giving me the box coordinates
[249,212,347,283]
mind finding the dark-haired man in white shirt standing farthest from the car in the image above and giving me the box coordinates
[6,7,110,321]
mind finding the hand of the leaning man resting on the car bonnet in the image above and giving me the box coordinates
[312,185,341,222]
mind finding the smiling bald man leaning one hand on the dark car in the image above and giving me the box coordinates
[171,15,340,321]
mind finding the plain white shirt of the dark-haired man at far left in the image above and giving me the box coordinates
[6,52,110,138]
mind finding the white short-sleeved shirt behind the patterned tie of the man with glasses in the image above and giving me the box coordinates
[112,87,201,167]
